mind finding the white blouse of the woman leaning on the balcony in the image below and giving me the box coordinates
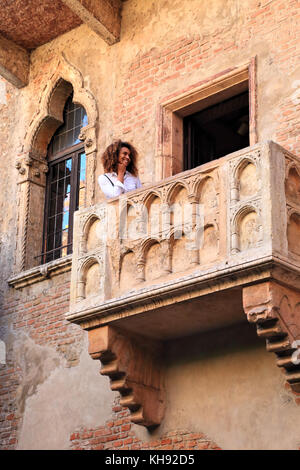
[98,171,142,199]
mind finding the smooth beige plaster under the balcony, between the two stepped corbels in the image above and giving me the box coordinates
[163,325,300,450]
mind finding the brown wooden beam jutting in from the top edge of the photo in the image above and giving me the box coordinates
[62,0,121,45]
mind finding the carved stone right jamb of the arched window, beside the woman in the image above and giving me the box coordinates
[79,123,97,207]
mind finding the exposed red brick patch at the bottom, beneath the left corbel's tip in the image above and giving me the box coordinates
[70,402,221,450]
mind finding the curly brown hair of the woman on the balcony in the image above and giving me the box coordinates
[102,140,138,176]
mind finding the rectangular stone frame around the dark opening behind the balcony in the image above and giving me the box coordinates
[155,57,258,181]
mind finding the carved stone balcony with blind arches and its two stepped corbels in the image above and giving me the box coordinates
[67,142,300,426]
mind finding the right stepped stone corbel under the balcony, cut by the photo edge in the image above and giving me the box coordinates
[243,281,300,393]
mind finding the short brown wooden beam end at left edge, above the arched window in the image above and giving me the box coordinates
[0,35,30,88]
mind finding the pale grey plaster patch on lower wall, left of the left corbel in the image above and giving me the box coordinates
[17,338,116,450]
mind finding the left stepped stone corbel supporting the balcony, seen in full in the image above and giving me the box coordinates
[88,326,165,427]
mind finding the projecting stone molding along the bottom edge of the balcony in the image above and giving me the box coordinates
[66,257,300,329]
